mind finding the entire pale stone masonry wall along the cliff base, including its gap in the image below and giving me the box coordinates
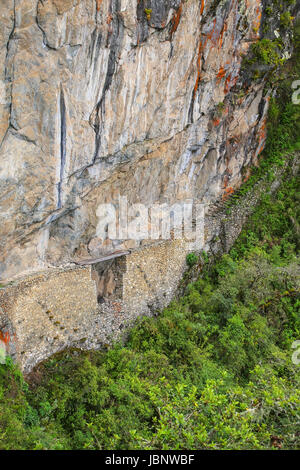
[0,153,300,372]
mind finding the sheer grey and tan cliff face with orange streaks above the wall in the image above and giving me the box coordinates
[0,0,296,281]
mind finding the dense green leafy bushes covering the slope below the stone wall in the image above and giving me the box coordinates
[0,156,300,449]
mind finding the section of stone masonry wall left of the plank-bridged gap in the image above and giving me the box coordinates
[0,267,98,371]
